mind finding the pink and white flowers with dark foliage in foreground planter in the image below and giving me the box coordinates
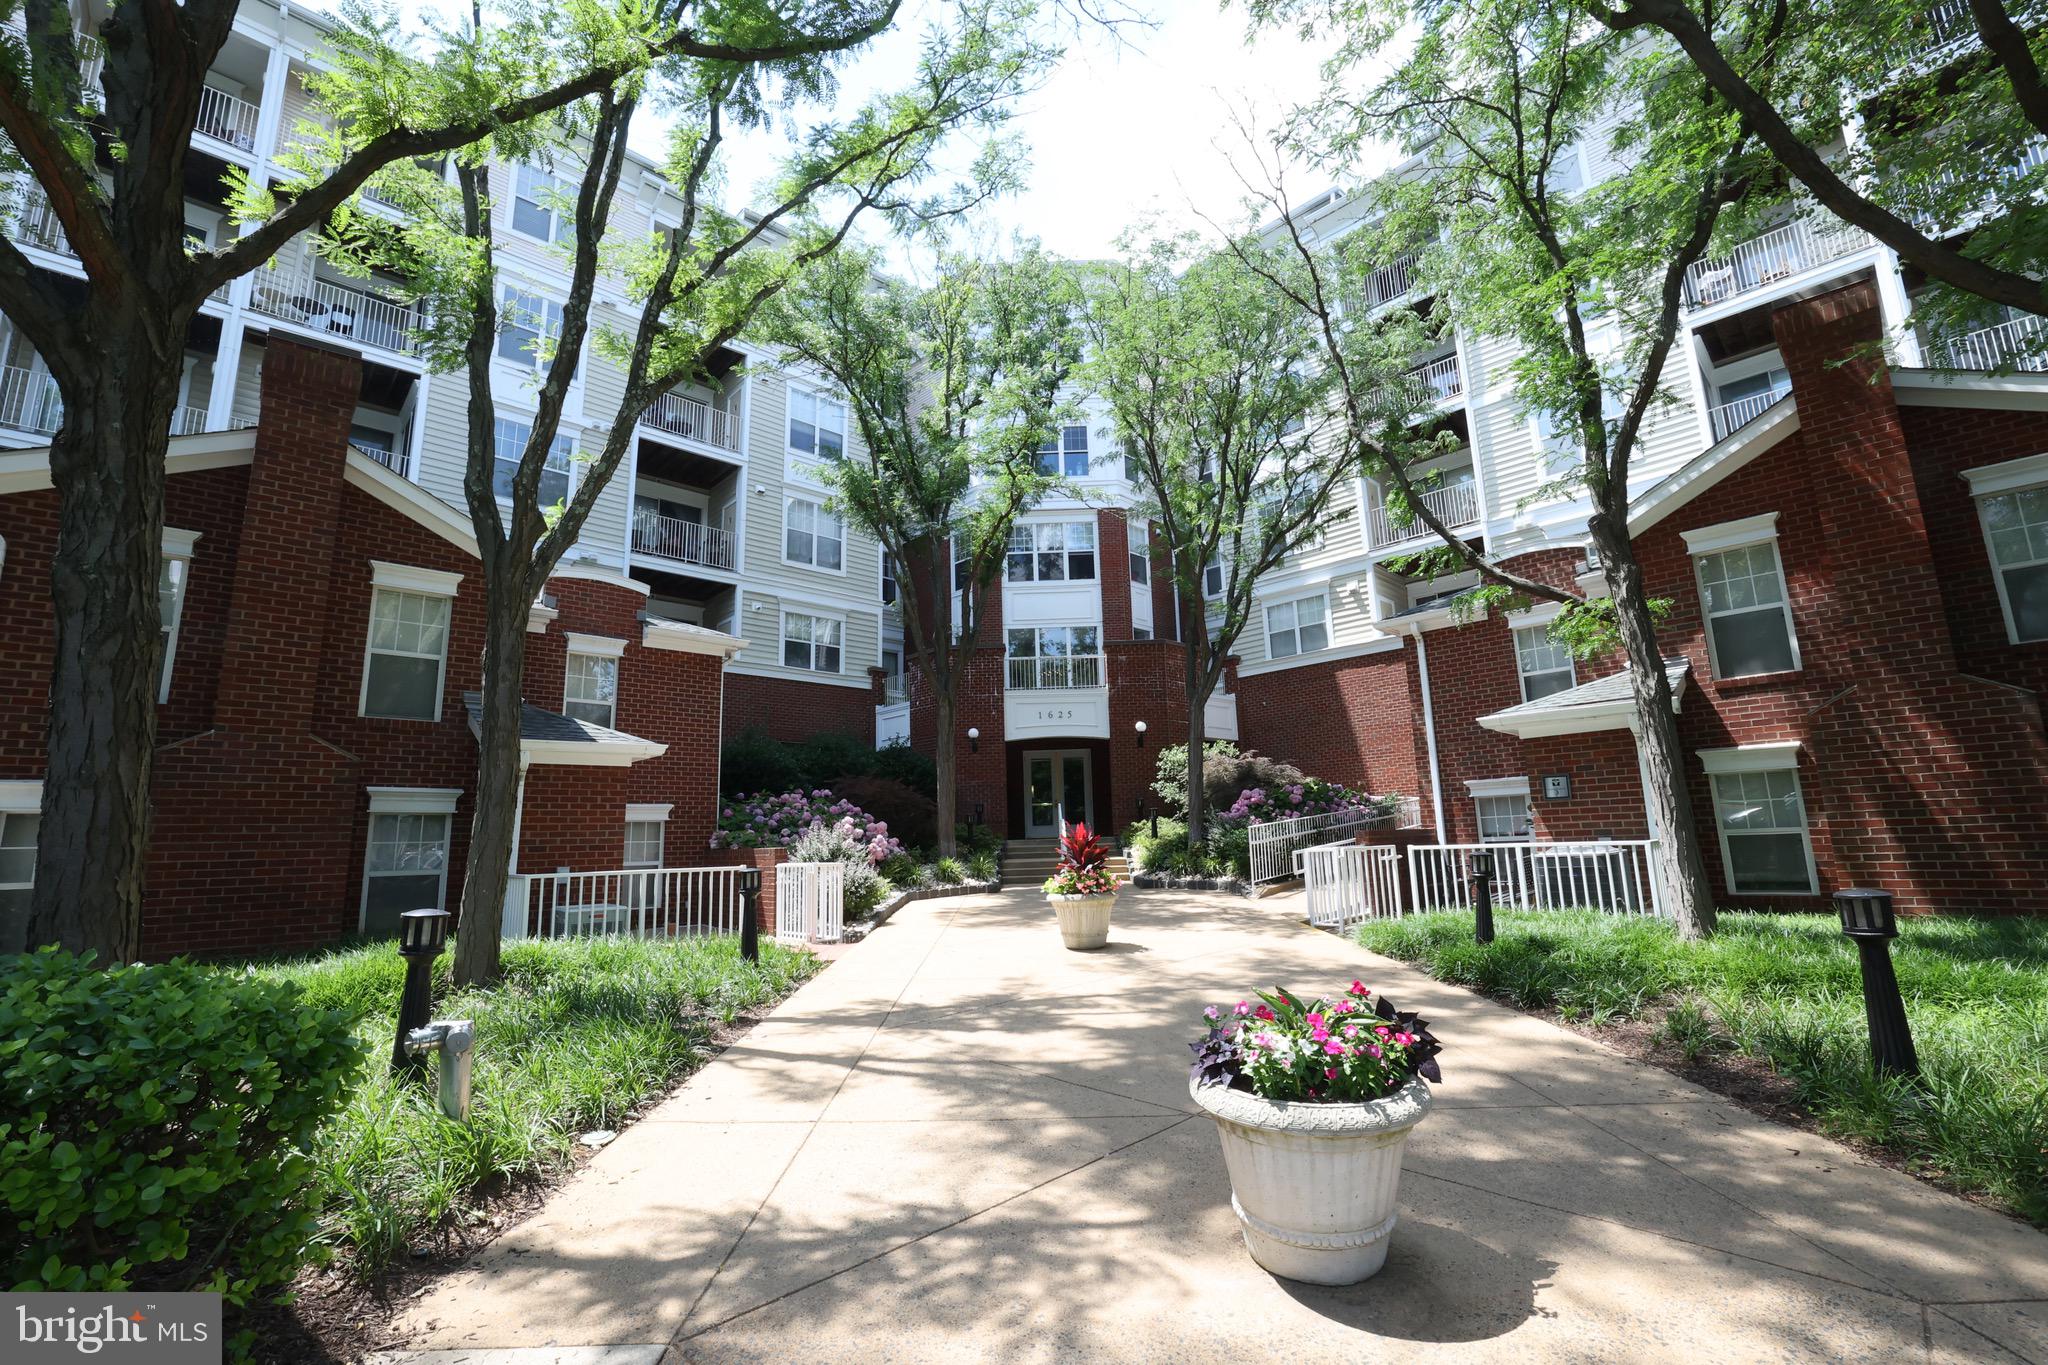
[1188,980,1444,1105]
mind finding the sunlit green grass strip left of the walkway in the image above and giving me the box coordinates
[250,939,817,1277]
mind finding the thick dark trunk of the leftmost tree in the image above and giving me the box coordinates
[22,339,178,964]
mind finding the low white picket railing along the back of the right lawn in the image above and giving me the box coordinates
[1407,839,1663,915]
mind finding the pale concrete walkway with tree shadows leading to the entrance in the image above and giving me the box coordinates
[380,892,2048,1365]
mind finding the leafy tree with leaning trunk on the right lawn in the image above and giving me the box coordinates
[1257,0,1769,937]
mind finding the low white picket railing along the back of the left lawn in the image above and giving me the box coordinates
[506,868,750,939]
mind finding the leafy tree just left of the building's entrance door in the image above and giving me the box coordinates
[766,236,1079,857]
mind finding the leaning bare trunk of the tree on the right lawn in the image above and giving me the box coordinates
[1593,516,1714,939]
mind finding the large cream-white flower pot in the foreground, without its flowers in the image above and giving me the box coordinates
[1188,1076,1430,1285]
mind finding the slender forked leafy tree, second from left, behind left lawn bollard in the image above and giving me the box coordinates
[344,0,1051,984]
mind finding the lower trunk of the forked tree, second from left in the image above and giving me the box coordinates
[455,569,530,986]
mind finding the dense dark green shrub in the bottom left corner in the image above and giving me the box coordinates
[0,948,365,1304]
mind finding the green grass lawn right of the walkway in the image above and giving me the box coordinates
[1358,911,2048,1228]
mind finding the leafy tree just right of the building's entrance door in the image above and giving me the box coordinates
[1087,237,1405,845]
